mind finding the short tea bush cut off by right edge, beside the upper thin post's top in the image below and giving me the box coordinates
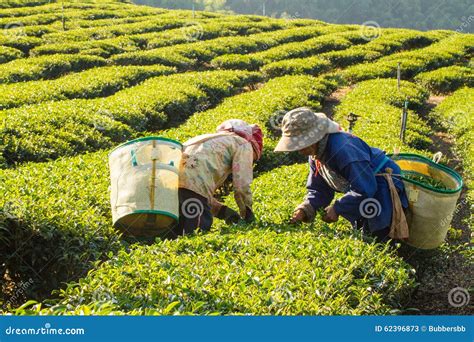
[415,65,474,94]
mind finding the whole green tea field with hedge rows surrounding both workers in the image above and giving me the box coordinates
[0,0,474,315]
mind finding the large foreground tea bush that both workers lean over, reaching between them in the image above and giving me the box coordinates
[14,165,415,315]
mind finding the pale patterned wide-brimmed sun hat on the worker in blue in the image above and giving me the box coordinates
[275,107,341,152]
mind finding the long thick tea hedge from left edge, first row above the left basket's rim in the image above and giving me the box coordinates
[0,71,259,164]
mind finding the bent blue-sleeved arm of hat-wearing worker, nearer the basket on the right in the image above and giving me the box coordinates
[334,161,380,222]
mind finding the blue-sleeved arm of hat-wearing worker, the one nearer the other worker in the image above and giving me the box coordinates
[295,160,334,222]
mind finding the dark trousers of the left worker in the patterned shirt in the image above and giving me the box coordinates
[173,188,213,236]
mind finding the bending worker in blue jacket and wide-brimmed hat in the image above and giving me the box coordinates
[275,108,408,241]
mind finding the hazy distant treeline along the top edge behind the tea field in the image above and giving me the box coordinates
[133,0,474,33]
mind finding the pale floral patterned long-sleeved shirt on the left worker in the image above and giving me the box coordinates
[179,134,253,217]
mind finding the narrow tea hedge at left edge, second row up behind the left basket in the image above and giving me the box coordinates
[0,65,175,109]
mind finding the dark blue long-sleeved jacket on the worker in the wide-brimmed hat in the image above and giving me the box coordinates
[307,132,408,231]
